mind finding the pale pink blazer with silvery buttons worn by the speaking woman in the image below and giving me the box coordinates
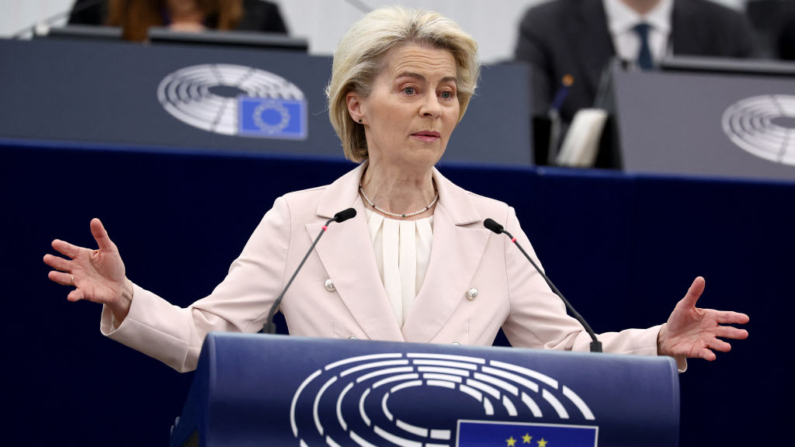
[101,166,659,371]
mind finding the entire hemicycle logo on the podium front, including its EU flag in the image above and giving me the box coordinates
[290,352,599,447]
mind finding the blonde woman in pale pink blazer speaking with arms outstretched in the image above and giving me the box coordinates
[44,7,748,371]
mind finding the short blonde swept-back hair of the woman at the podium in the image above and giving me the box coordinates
[326,6,480,163]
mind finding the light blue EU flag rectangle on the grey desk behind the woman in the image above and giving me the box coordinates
[238,96,307,140]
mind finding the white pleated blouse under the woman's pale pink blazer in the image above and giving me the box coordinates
[365,208,433,327]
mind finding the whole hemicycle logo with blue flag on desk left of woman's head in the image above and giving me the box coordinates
[157,64,308,140]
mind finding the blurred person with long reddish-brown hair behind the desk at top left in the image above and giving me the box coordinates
[69,0,287,42]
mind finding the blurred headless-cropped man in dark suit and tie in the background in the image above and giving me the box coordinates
[516,0,755,123]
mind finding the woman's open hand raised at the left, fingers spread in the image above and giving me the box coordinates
[44,219,133,322]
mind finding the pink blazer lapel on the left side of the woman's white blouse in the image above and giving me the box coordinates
[306,166,403,341]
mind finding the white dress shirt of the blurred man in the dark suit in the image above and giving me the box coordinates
[602,0,674,63]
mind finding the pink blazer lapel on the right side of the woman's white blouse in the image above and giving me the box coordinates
[403,170,490,343]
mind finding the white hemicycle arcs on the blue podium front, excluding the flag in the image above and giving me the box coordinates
[290,353,595,447]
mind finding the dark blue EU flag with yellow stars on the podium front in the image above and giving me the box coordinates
[457,421,599,447]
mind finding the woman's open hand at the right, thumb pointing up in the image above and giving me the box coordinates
[657,276,748,361]
